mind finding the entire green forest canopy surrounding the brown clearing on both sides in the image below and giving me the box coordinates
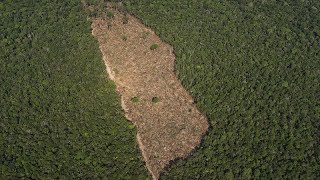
[0,0,320,180]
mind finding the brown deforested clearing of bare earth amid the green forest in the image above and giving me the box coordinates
[92,12,208,179]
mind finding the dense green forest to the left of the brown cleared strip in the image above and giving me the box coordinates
[0,0,148,180]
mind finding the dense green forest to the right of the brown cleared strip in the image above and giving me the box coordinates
[125,0,320,179]
